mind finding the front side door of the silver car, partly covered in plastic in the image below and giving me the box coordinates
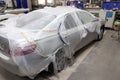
[70,11,98,51]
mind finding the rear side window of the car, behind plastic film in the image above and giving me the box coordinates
[64,14,77,29]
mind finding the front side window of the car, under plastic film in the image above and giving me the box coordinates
[77,12,94,24]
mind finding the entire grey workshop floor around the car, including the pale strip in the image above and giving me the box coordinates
[0,31,120,80]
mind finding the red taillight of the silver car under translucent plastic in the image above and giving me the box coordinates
[8,44,37,56]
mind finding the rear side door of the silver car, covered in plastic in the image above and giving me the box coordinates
[60,13,80,53]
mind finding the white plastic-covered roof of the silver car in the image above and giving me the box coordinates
[36,6,83,16]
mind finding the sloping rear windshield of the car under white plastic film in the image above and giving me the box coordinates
[16,12,56,29]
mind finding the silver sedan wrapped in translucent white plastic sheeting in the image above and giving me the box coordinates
[0,7,104,79]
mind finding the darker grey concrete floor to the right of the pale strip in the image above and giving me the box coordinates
[68,31,120,80]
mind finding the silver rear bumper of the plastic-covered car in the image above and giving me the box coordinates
[0,52,51,77]
